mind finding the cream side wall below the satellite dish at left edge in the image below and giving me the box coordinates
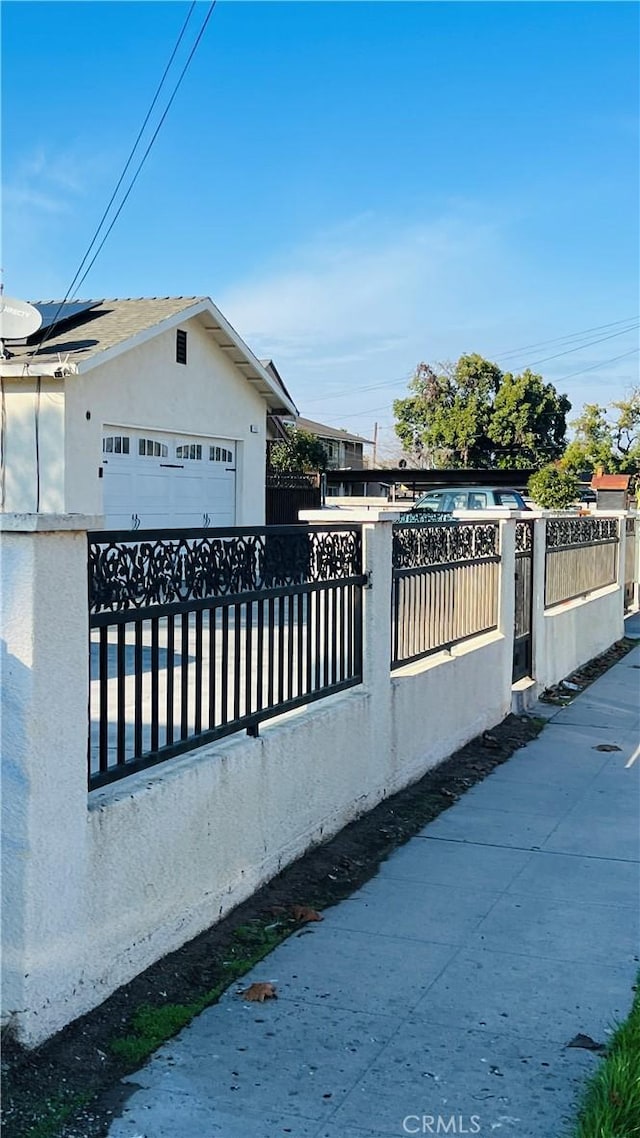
[0,378,65,513]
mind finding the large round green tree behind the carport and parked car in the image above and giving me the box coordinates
[393,354,571,470]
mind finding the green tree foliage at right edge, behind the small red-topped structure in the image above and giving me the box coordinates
[561,387,640,475]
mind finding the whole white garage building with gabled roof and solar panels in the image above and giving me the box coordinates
[0,297,297,529]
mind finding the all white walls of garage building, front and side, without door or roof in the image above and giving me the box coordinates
[3,318,266,526]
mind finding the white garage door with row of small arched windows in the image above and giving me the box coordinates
[102,427,236,529]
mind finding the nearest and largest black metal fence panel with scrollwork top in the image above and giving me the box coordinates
[89,525,367,789]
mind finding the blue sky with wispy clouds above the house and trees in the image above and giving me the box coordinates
[2,0,640,453]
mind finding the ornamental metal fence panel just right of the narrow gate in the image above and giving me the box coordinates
[544,517,620,609]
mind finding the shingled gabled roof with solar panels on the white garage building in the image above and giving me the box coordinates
[0,296,297,414]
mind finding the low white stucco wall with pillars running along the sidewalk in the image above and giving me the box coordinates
[0,518,622,1046]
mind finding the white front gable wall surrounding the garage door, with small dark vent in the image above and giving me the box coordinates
[65,318,266,526]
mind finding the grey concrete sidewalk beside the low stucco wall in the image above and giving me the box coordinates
[109,646,640,1138]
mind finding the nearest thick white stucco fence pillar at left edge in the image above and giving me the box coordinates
[0,514,97,1046]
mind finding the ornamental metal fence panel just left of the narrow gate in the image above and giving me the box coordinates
[391,519,500,668]
